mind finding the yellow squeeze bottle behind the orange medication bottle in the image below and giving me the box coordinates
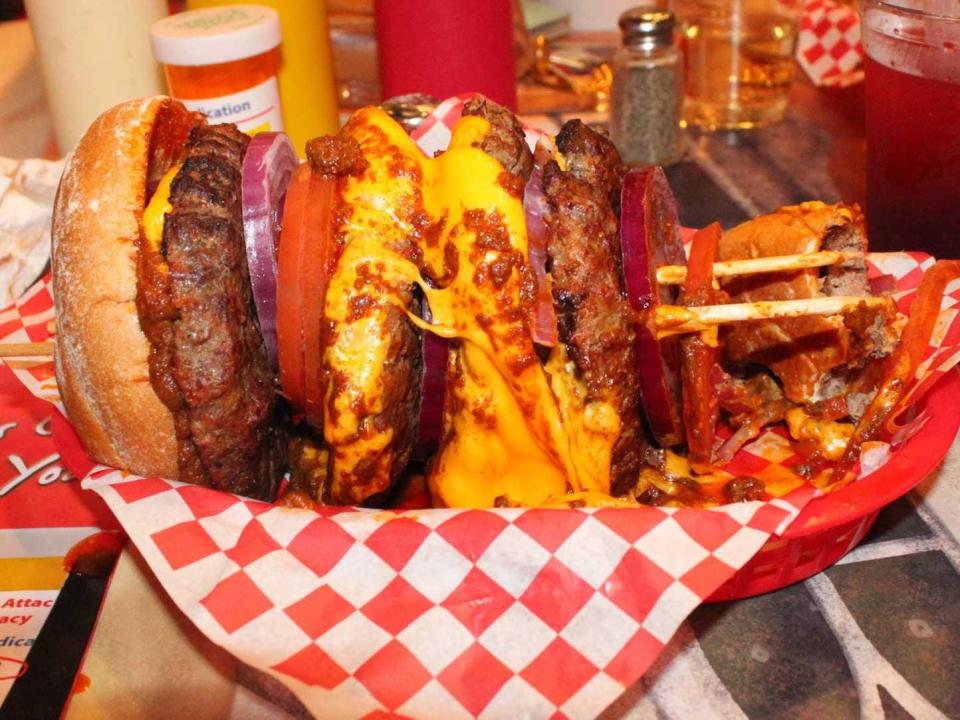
[187,0,340,157]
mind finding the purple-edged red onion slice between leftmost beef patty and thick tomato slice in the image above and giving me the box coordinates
[240,132,299,368]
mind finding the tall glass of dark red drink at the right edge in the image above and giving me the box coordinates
[860,0,960,258]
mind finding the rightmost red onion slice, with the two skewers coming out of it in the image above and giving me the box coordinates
[620,167,686,447]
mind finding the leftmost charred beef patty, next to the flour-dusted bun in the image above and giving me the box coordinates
[137,125,285,498]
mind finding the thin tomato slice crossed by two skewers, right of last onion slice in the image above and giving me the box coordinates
[680,223,721,470]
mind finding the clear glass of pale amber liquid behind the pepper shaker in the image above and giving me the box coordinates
[674,0,802,130]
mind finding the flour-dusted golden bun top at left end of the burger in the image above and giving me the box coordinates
[51,97,197,478]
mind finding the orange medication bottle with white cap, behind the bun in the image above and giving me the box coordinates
[150,5,283,135]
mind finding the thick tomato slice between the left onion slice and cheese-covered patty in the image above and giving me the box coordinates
[277,164,338,427]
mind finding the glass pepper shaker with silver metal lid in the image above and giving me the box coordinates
[610,7,683,165]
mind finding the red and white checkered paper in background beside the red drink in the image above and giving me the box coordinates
[797,0,863,87]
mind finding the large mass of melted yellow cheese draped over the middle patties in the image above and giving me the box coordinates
[324,108,620,507]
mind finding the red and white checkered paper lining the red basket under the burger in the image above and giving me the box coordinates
[0,111,960,718]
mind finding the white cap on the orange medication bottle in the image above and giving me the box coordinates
[150,5,280,65]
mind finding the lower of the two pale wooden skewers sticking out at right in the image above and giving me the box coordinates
[652,296,891,338]
